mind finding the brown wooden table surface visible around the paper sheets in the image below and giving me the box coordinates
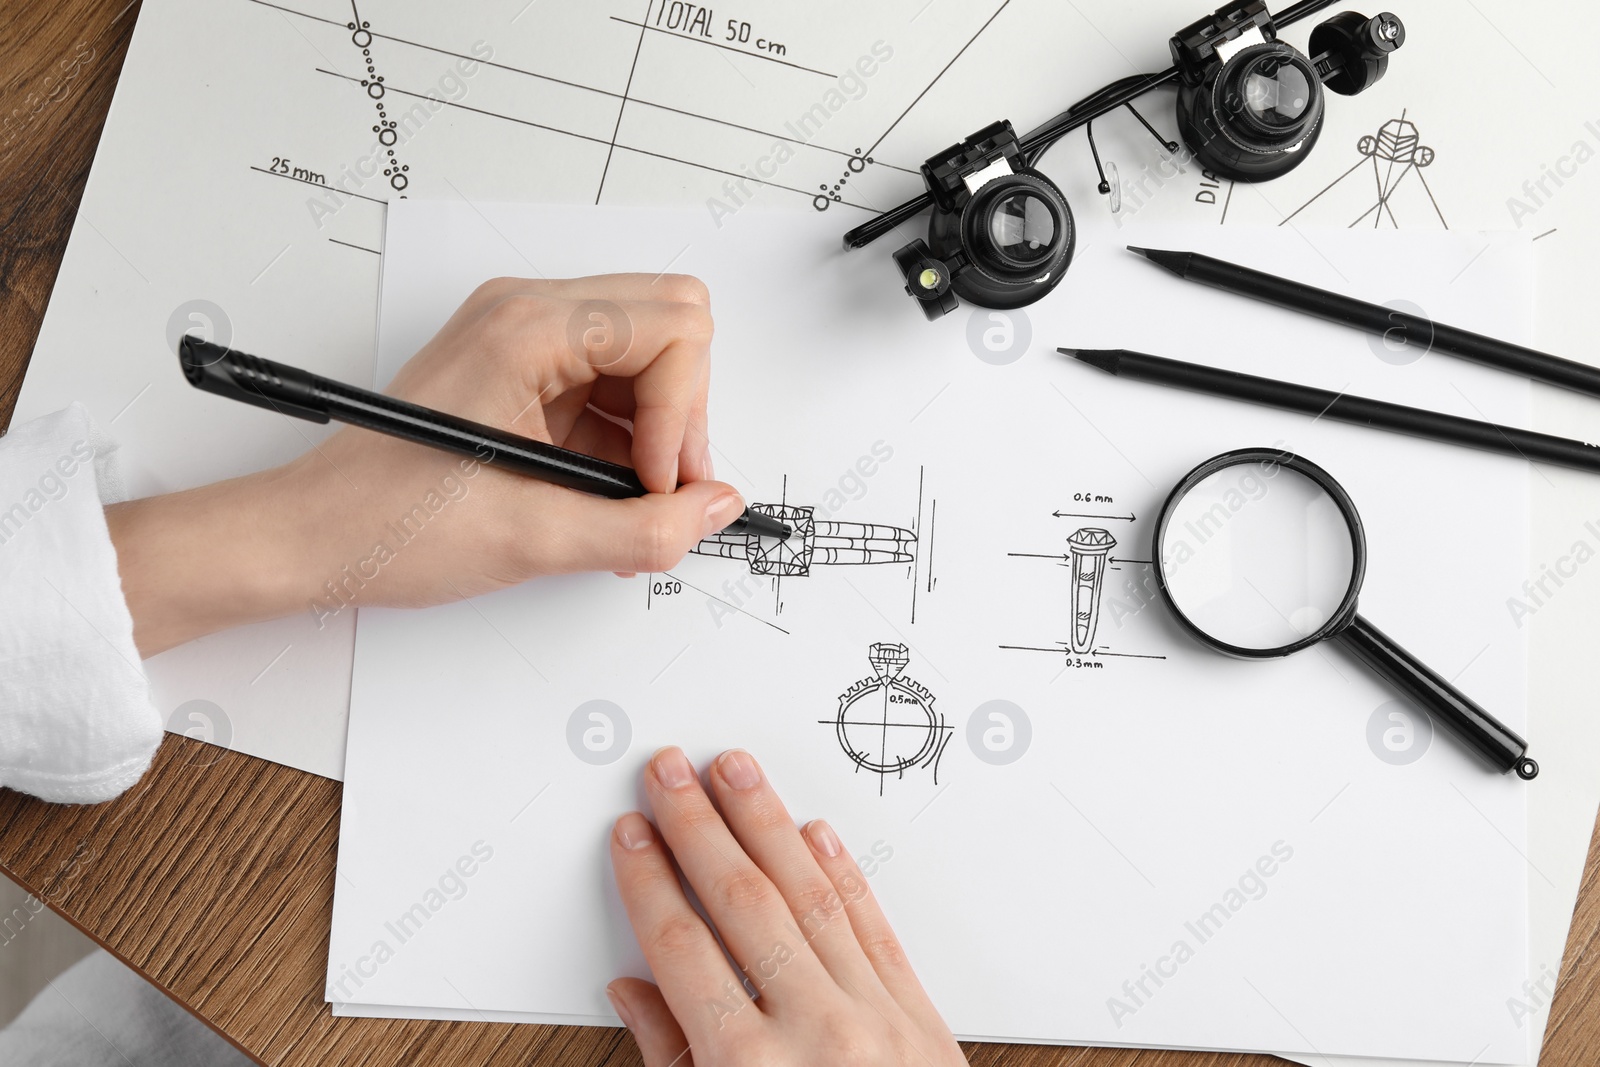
[0,0,1600,1067]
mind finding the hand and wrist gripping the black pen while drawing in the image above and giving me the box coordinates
[107,275,744,656]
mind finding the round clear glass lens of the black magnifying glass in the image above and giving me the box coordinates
[1160,464,1357,651]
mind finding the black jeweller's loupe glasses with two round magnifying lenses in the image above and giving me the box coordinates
[845,0,1405,320]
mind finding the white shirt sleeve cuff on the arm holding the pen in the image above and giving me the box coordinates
[0,403,162,803]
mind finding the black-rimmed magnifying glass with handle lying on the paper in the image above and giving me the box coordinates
[1150,448,1539,781]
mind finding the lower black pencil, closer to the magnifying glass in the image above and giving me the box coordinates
[1058,349,1600,472]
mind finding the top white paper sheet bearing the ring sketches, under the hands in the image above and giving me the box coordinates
[330,203,1531,1062]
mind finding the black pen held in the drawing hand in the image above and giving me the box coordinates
[178,334,794,539]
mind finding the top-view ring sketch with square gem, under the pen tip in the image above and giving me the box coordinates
[690,504,917,577]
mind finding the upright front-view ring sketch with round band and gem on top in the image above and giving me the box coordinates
[818,641,952,797]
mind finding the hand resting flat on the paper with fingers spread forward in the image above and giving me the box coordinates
[606,749,966,1067]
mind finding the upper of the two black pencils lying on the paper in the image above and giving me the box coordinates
[1128,245,1600,397]
